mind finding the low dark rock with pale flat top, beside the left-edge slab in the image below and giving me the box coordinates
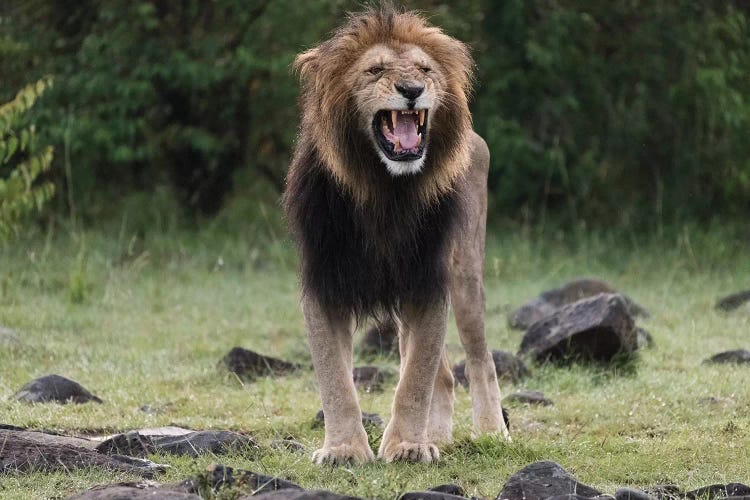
[96,431,258,457]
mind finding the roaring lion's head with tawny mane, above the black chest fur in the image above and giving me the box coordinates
[295,7,473,201]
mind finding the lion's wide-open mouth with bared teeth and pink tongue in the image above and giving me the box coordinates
[372,109,429,161]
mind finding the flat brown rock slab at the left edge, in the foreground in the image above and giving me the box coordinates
[0,430,166,478]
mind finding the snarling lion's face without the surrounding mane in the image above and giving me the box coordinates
[348,44,445,175]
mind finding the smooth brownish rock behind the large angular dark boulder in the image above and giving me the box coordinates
[508,278,649,330]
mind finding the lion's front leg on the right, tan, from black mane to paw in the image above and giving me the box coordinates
[378,302,452,462]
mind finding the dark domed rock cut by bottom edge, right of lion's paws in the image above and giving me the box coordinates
[496,462,601,500]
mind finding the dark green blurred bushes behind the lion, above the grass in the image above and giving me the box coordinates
[0,0,750,239]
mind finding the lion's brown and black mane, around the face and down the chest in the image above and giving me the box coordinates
[283,7,472,316]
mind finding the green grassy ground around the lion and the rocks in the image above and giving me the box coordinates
[0,221,750,498]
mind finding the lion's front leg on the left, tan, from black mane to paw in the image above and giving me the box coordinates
[302,296,375,465]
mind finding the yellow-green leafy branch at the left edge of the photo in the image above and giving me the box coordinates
[0,80,54,240]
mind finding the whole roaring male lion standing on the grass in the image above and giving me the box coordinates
[284,7,510,464]
